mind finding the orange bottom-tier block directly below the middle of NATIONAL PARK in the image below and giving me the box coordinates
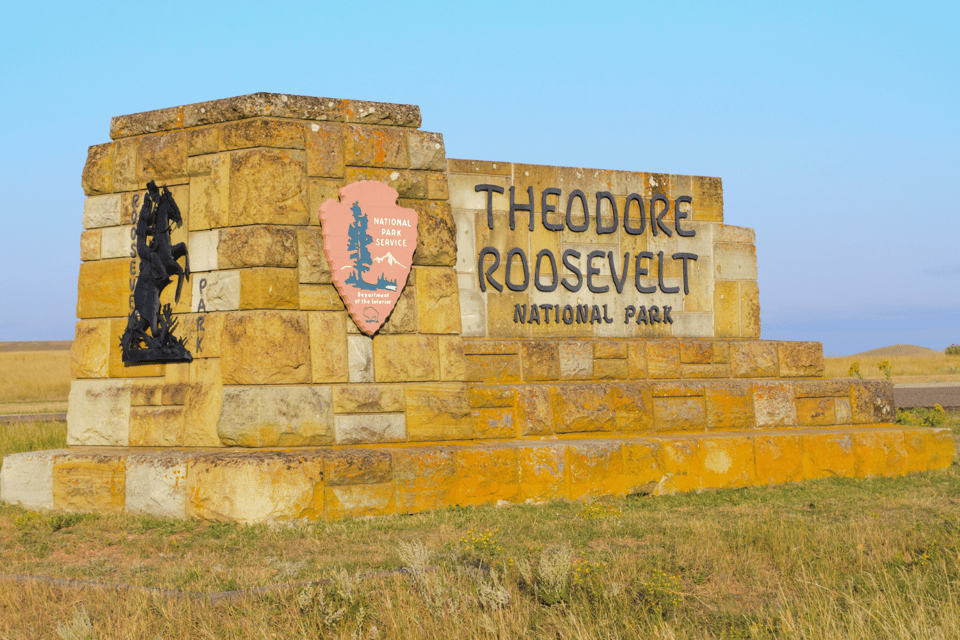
[567,440,627,500]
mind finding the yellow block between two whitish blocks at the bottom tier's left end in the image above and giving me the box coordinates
[53,453,126,513]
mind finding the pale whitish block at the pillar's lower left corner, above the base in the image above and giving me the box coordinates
[67,380,130,447]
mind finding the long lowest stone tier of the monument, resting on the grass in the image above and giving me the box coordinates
[0,424,955,523]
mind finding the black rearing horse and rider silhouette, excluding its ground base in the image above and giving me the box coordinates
[131,180,190,344]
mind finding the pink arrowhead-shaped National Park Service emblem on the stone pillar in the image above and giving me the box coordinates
[320,180,417,335]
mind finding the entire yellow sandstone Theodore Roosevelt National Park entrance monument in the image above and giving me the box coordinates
[0,93,954,522]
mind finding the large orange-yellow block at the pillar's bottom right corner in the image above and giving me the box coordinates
[406,383,473,442]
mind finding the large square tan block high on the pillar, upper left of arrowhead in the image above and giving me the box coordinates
[228,149,310,226]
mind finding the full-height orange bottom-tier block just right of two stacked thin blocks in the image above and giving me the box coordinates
[393,447,457,513]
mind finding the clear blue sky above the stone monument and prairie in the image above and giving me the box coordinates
[0,1,960,354]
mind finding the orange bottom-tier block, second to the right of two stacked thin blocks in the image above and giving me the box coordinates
[456,447,520,505]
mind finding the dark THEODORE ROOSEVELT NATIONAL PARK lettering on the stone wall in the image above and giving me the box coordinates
[474,184,698,324]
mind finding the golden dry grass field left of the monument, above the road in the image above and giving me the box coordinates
[0,351,70,404]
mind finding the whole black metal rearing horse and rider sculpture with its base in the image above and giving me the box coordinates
[120,180,193,364]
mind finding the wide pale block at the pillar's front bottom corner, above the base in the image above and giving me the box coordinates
[217,385,333,447]
